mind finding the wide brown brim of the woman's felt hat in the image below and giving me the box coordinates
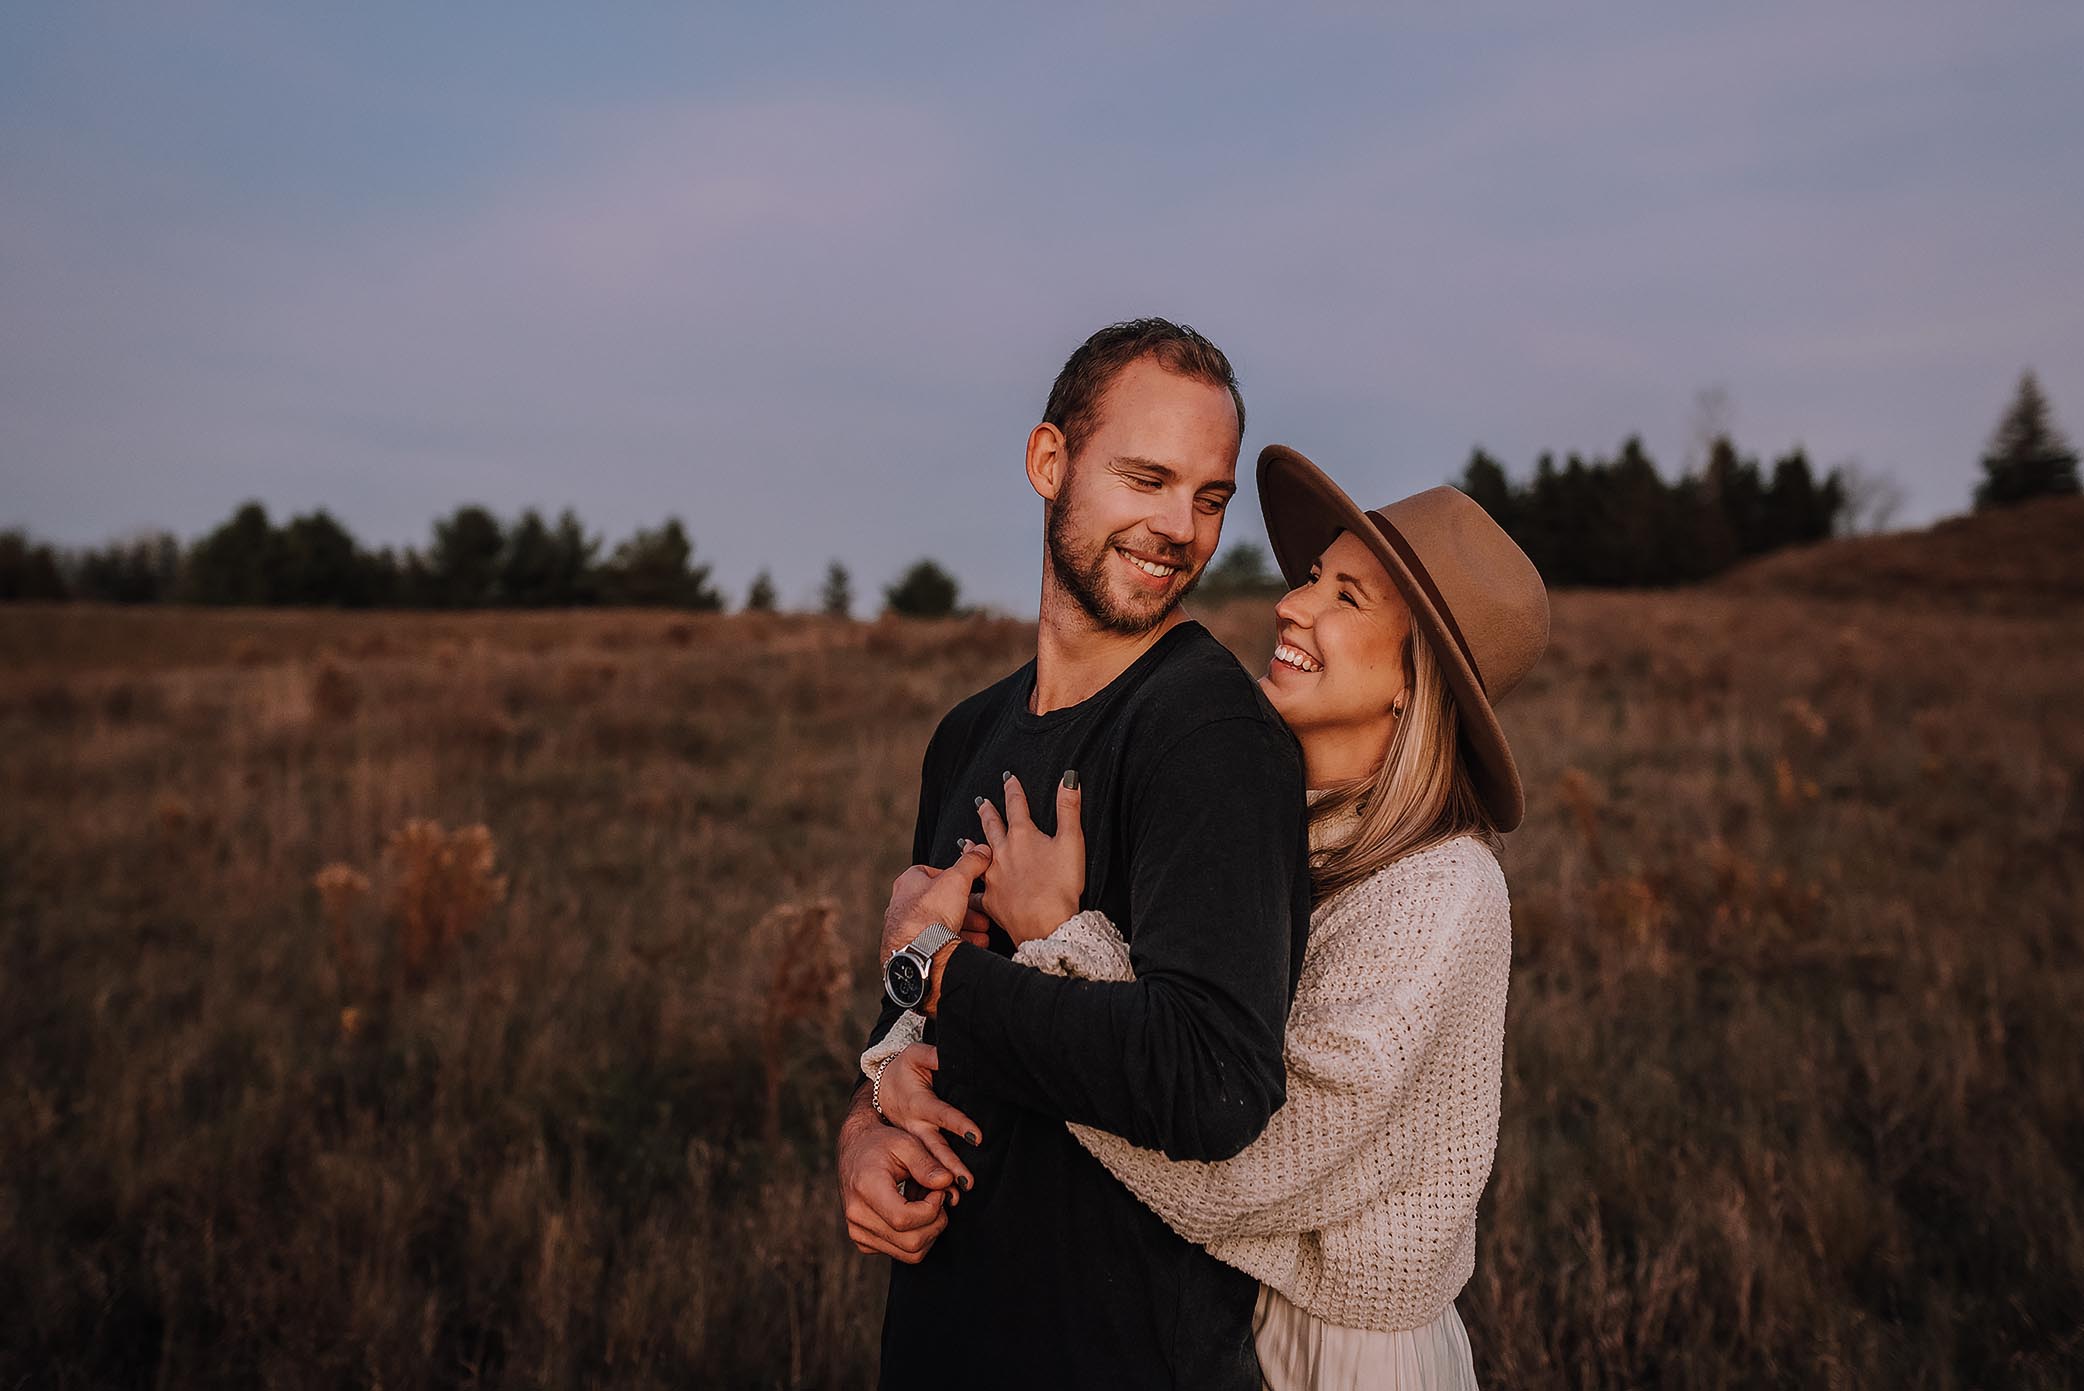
[1259,444,1528,830]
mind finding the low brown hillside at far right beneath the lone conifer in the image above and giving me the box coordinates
[1717,496,2084,611]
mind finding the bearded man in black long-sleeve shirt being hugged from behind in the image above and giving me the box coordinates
[838,319,1309,1391]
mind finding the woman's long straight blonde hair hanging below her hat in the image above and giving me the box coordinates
[1309,626,1505,903]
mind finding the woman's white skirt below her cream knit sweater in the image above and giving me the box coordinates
[1252,1285,1475,1391]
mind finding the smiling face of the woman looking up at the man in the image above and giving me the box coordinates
[1259,532,1411,776]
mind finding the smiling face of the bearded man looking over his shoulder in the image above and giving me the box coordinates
[1046,357,1240,636]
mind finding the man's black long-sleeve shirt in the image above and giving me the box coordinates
[875,621,1309,1391]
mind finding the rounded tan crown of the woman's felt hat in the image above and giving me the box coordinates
[1367,486,1548,701]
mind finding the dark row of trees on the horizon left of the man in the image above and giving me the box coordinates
[0,503,975,617]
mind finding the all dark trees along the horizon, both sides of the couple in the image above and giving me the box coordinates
[0,371,2078,604]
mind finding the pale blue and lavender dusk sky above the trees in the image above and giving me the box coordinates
[0,0,2084,611]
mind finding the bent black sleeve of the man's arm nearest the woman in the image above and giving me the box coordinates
[934,717,1303,1160]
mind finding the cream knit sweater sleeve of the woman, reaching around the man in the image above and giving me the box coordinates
[1042,872,1511,1243]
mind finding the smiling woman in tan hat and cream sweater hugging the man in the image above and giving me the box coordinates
[863,446,1548,1389]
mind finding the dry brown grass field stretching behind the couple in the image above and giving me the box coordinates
[0,527,2084,1391]
